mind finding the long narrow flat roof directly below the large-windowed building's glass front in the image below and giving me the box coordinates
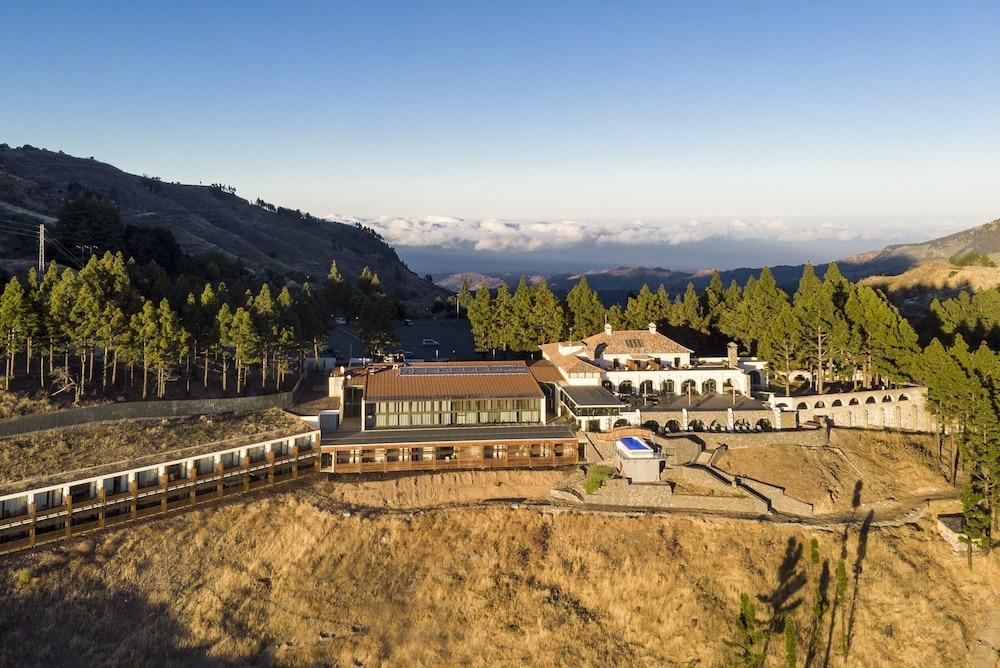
[322,425,576,447]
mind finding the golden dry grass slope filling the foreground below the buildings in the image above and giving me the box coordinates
[0,472,1000,666]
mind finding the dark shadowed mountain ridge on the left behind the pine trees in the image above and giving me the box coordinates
[0,145,444,302]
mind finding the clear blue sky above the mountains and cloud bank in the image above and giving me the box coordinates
[0,0,1000,222]
